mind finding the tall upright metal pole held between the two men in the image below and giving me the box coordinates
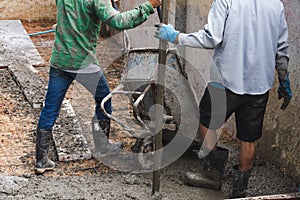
[152,0,168,194]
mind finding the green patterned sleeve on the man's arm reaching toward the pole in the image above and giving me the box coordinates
[94,0,154,30]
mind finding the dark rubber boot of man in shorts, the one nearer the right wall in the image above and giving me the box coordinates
[230,166,252,198]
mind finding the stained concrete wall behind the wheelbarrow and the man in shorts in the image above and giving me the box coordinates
[121,0,300,183]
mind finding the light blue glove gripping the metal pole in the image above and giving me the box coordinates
[155,24,179,43]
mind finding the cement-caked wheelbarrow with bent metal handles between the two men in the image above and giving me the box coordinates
[101,33,199,168]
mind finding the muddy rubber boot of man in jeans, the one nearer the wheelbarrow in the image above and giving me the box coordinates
[92,120,121,157]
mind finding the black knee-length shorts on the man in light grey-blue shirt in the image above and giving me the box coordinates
[199,85,269,142]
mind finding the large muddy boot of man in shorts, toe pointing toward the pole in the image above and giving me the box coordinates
[184,147,228,190]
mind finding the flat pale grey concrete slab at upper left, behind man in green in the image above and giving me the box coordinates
[0,20,45,67]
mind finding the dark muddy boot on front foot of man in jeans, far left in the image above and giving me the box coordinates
[35,129,55,174]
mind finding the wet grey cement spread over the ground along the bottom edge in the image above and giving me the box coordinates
[0,146,297,200]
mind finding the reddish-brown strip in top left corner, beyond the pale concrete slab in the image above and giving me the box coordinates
[0,0,56,20]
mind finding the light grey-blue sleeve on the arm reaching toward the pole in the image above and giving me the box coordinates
[178,0,229,49]
